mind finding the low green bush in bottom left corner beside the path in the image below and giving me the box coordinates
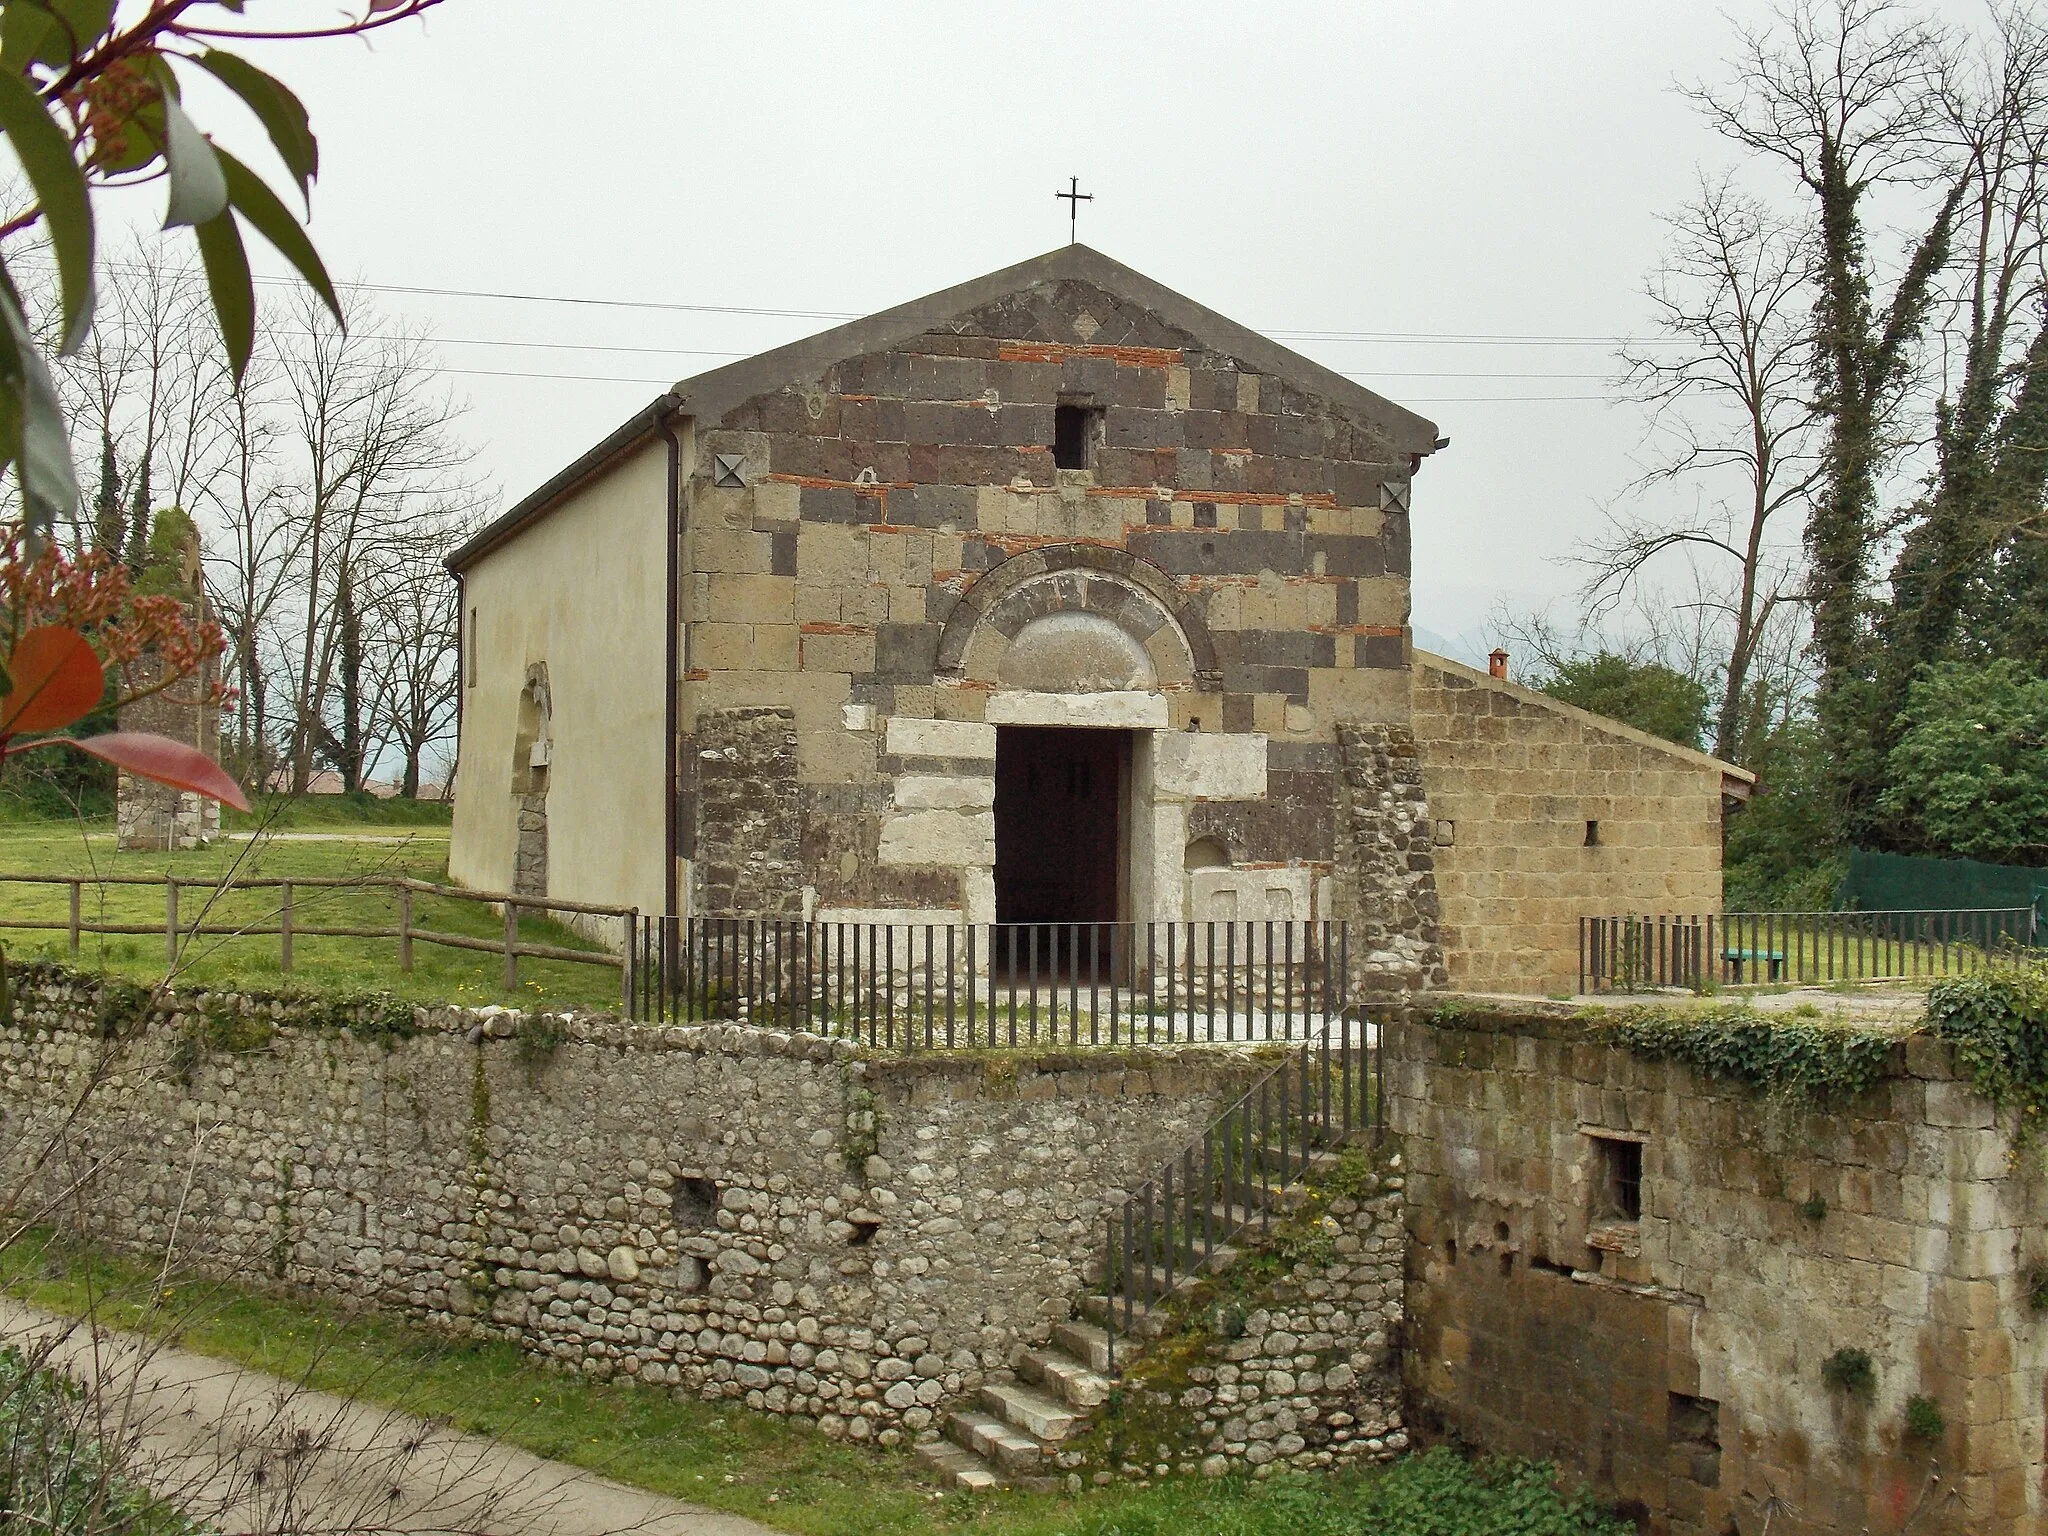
[0,1348,201,1536]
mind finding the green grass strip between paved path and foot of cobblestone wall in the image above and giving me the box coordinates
[0,1233,1632,1536]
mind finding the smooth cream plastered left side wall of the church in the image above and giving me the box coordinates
[449,442,668,925]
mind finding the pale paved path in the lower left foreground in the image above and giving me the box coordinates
[0,1298,772,1536]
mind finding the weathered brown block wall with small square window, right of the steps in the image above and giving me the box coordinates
[1386,1001,2048,1536]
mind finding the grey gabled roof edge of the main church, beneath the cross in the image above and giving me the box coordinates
[449,246,1438,571]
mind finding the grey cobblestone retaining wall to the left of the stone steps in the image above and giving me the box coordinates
[0,967,1264,1444]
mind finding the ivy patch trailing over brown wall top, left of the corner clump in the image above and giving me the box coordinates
[1599,1006,1892,1104]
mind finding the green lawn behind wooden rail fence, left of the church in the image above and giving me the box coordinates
[0,821,621,1024]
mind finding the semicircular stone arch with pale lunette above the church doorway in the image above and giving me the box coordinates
[938,545,1221,692]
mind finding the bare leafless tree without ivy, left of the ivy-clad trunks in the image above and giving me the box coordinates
[1577,182,1819,760]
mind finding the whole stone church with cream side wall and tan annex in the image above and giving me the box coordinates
[451,246,1749,991]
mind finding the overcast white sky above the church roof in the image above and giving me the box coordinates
[99,0,1976,653]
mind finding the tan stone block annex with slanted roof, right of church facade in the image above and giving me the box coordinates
[1413,655,1749,993]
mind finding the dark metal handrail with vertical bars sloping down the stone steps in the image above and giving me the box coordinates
[1102,1008,1386,1372]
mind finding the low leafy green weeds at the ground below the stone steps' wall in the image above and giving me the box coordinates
[1067,1448,1634,1536]
